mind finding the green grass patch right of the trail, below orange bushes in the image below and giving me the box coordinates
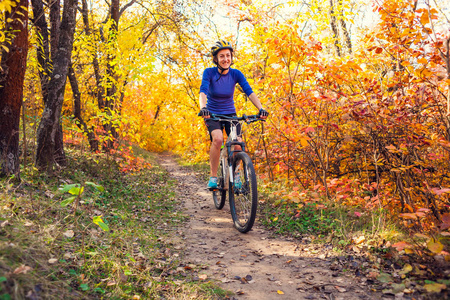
[258,193,403,251]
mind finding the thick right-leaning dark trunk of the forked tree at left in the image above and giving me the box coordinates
[33,0,77,173]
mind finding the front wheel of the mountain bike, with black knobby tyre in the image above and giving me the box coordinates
[229,152,258,233]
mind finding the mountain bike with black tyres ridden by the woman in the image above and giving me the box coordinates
[204,114,265,233]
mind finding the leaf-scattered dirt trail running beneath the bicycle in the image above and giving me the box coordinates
[159,154,383,300]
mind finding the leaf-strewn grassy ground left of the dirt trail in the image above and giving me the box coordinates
[0,149,228,299]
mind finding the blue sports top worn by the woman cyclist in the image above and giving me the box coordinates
[200,67,253,114]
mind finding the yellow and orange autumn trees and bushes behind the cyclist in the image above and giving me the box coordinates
[0,0,450,298]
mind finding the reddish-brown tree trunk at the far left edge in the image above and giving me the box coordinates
[0,0,28,179]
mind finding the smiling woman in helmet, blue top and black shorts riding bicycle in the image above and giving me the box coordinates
[199,40,269,189]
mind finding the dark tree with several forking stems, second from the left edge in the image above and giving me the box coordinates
[32,0,77,172]
